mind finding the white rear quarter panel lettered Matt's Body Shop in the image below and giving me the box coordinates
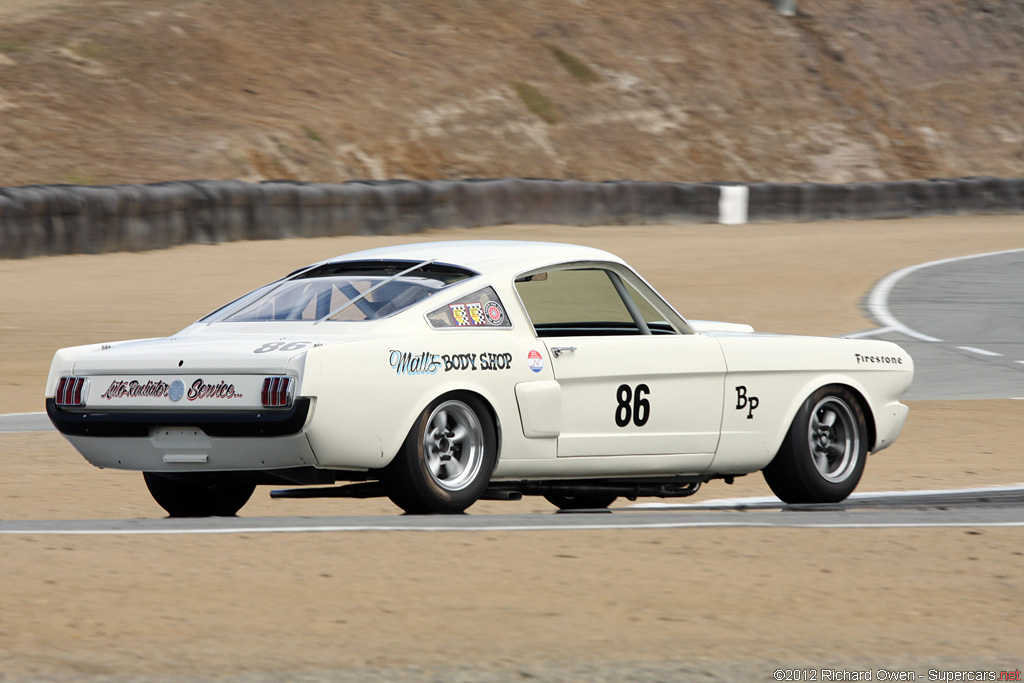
[300,328,555,469]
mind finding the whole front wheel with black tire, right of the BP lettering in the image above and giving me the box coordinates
[764,385,867,505]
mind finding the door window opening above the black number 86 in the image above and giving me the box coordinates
[515,268,675,337]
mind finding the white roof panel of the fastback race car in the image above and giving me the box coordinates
[325,240,625,274]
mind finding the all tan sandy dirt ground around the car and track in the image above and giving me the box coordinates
[0,217,1024,683]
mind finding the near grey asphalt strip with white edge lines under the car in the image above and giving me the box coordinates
[0,484,1024,536]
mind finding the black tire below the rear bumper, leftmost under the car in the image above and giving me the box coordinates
[142,472,256,517]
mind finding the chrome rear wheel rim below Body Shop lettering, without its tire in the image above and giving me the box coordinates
[423,400,484,490]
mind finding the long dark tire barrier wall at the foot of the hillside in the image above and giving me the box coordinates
[0,177,1024,258]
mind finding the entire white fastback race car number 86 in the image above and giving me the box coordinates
[46,241,913,516]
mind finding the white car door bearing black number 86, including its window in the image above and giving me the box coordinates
[516,263,725,464]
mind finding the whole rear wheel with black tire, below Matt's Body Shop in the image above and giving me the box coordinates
[381,393,498,514]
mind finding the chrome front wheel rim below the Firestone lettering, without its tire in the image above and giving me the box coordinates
[807,396,860,483]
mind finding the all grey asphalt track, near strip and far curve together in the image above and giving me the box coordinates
[0,249,1024,535]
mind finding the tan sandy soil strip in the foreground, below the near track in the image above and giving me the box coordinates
[0,528,1024,681]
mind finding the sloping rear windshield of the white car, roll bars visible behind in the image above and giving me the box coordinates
[201,261,476,323]
